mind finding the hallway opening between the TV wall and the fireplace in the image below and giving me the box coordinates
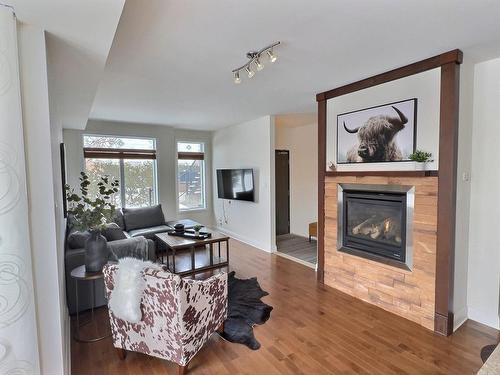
[273,113,318,269]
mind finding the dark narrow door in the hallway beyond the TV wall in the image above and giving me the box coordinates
[275,150,290,236]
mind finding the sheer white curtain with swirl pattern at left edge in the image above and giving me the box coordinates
[0,4,40,374]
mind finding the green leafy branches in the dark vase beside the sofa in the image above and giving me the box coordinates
[64,172,120,231]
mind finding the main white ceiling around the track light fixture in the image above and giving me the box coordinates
[43,0,500,129]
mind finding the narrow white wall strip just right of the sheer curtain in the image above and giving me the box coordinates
[19,24,70,374]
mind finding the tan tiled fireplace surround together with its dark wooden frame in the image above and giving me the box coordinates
[316,49,466,336]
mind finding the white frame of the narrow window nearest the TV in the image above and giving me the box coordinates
[175,138,208,213]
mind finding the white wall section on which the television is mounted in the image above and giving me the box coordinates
[212,116,276,252]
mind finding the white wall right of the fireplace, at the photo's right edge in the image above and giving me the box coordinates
[467,59,500,328]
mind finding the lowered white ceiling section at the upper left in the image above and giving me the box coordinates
[6,0,125,129]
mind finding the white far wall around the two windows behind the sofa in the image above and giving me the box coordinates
[64,120,214,225]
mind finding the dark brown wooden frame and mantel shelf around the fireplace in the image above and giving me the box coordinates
[316,49,463,335]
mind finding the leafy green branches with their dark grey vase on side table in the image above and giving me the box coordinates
[65,172,119,272]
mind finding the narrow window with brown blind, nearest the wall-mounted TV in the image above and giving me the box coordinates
[177,142,206,211]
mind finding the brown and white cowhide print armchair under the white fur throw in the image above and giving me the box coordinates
[103,264,227,374]
